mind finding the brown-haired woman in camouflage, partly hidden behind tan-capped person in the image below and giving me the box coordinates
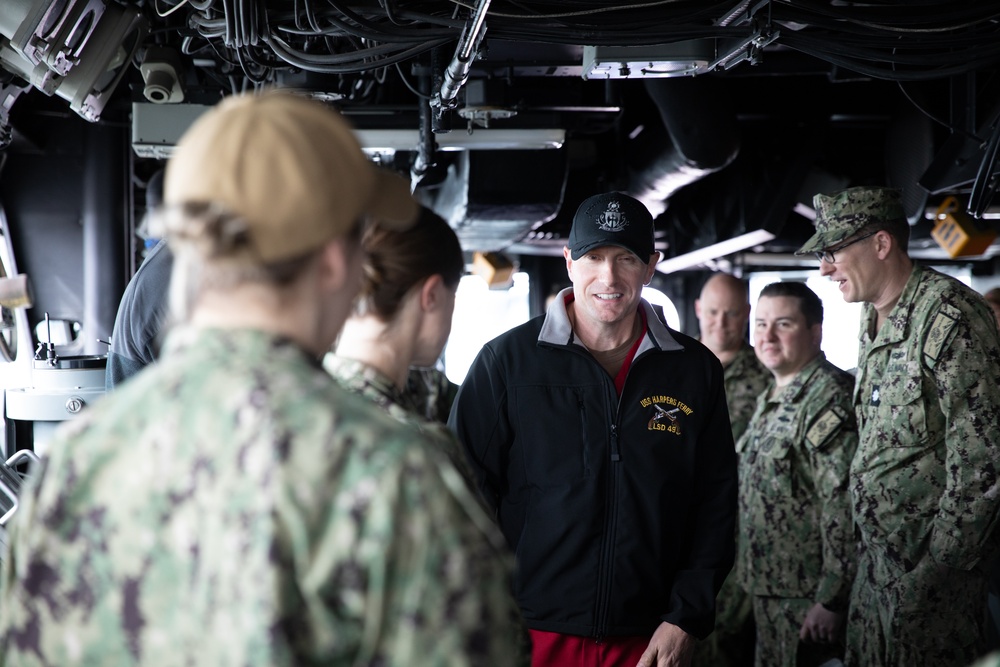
[323,207,472,482]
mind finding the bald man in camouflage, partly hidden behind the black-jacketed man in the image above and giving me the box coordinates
[693,273,771,667]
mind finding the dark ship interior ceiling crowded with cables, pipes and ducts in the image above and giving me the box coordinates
[0,0,1000,354]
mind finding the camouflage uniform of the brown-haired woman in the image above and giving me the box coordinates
[323,354,475,489]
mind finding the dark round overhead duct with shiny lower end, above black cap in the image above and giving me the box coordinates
[628,78,740,216]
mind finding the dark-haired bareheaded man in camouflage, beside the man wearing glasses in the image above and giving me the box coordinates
[736,282,858,667]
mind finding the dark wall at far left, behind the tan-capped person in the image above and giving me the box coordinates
[0,99,133,355]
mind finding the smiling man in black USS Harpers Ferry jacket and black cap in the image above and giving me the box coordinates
[449,192,736,667]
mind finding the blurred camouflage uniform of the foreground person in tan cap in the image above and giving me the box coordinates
[0,329,523,667]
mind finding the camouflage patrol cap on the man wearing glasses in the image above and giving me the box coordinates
[795,186,906,255]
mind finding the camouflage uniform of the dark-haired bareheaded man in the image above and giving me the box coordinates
[736,353,858,667]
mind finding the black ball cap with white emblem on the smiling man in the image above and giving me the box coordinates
[569,192,656,263]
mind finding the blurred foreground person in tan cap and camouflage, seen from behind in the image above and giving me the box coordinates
[0,92,523,667]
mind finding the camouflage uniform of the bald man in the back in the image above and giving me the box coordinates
[693,342,771,667]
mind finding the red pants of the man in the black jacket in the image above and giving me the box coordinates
[530,630,650,667]
